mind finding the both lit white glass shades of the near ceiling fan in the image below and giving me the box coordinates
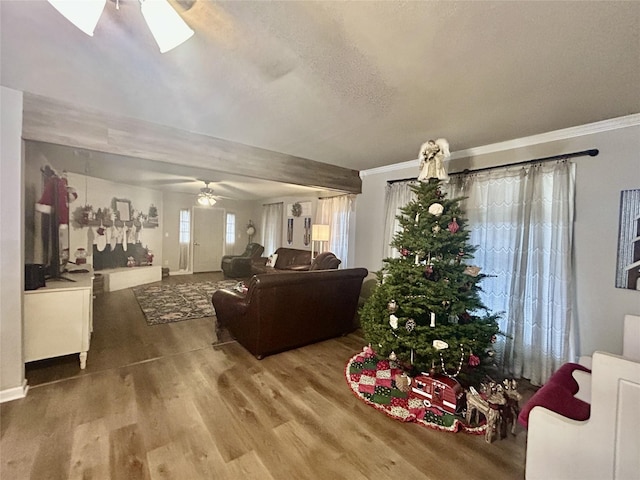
[47,0,194,53]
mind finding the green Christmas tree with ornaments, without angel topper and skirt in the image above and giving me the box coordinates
[360,144,499,385]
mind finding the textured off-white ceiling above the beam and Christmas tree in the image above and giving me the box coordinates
[0,0,640,195]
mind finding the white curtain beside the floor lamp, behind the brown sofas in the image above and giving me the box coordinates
[315,195,354,268]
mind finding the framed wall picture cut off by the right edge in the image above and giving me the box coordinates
[616,189,640,290]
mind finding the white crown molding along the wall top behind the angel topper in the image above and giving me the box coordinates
[360,113,640,177]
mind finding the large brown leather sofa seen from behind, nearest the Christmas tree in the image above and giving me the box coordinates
[212,268,368,359]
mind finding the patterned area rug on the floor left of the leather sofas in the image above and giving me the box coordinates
[133,280,238,325]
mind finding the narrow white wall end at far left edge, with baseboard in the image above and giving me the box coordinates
[0,86,27,401]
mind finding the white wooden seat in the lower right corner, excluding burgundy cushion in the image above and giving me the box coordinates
[525,315,640,480]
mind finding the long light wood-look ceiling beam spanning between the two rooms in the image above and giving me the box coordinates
[22,92,362,194]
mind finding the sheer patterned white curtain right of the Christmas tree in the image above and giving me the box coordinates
[449,161,575,385]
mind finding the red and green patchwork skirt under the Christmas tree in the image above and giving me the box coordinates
[345,352,486,435]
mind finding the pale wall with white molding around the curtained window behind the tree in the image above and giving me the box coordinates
[355,115,640,355]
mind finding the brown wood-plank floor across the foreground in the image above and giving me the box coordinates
[0,274,526,480]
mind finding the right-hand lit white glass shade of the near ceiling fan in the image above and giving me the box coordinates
[140,0,193,53]
